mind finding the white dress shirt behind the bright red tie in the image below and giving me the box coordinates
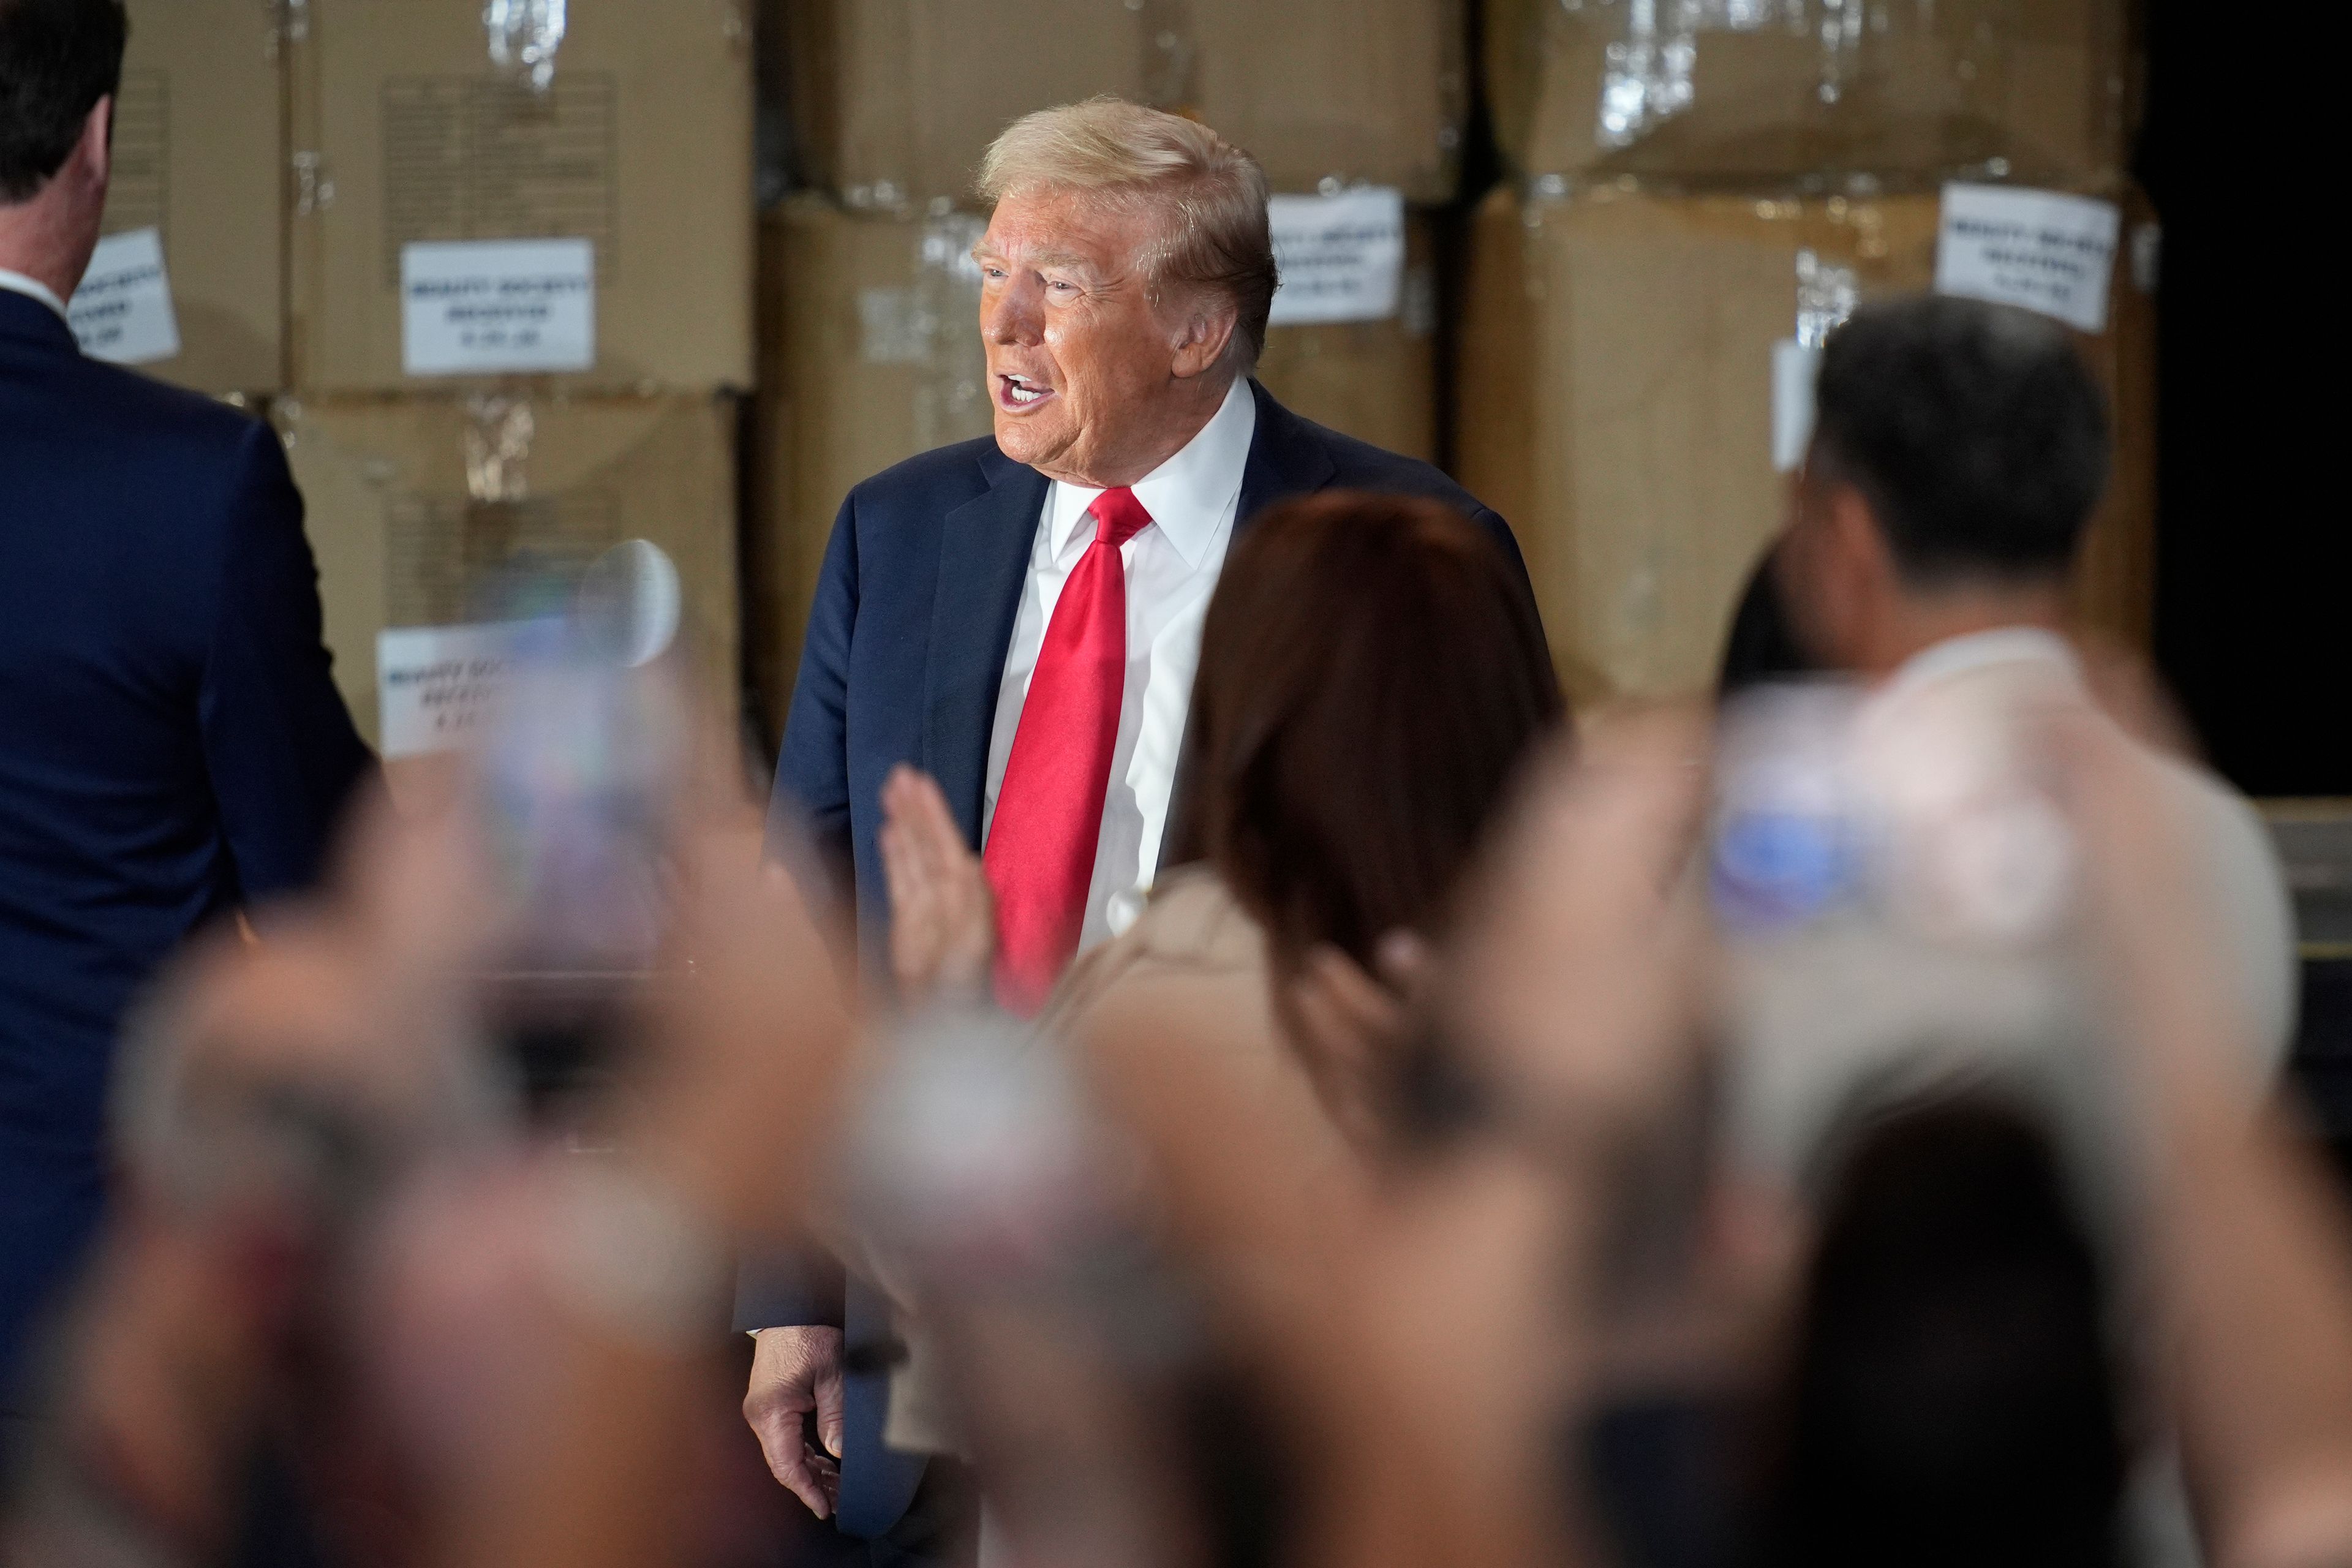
[981,376,1258,950]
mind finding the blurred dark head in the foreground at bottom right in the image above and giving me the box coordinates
[1769,1091,2126,1568]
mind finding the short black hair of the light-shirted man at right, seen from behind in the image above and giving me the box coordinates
[1811,296,2108,590]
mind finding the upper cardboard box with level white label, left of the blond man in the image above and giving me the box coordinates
[292,0,753,393]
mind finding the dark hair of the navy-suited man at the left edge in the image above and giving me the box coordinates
[0,0,129,202]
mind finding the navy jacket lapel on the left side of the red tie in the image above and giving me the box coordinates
[922,449,1049,844]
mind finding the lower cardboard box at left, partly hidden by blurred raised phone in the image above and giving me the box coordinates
[275,398,741,741]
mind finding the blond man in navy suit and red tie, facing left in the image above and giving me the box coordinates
[739,101,1524,1563]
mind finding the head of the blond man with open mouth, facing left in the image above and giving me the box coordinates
[971,99,1275,489]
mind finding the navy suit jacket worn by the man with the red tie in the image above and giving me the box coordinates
[736,383,1524,1535]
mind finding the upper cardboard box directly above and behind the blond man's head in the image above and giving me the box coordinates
[788,0,1468,211]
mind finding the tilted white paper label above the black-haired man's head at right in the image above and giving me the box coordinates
[1936,186,2122,331]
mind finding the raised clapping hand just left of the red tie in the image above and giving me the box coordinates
[882,766,997,1004]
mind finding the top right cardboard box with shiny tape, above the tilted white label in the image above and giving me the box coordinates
[1484,0,2128,183]
